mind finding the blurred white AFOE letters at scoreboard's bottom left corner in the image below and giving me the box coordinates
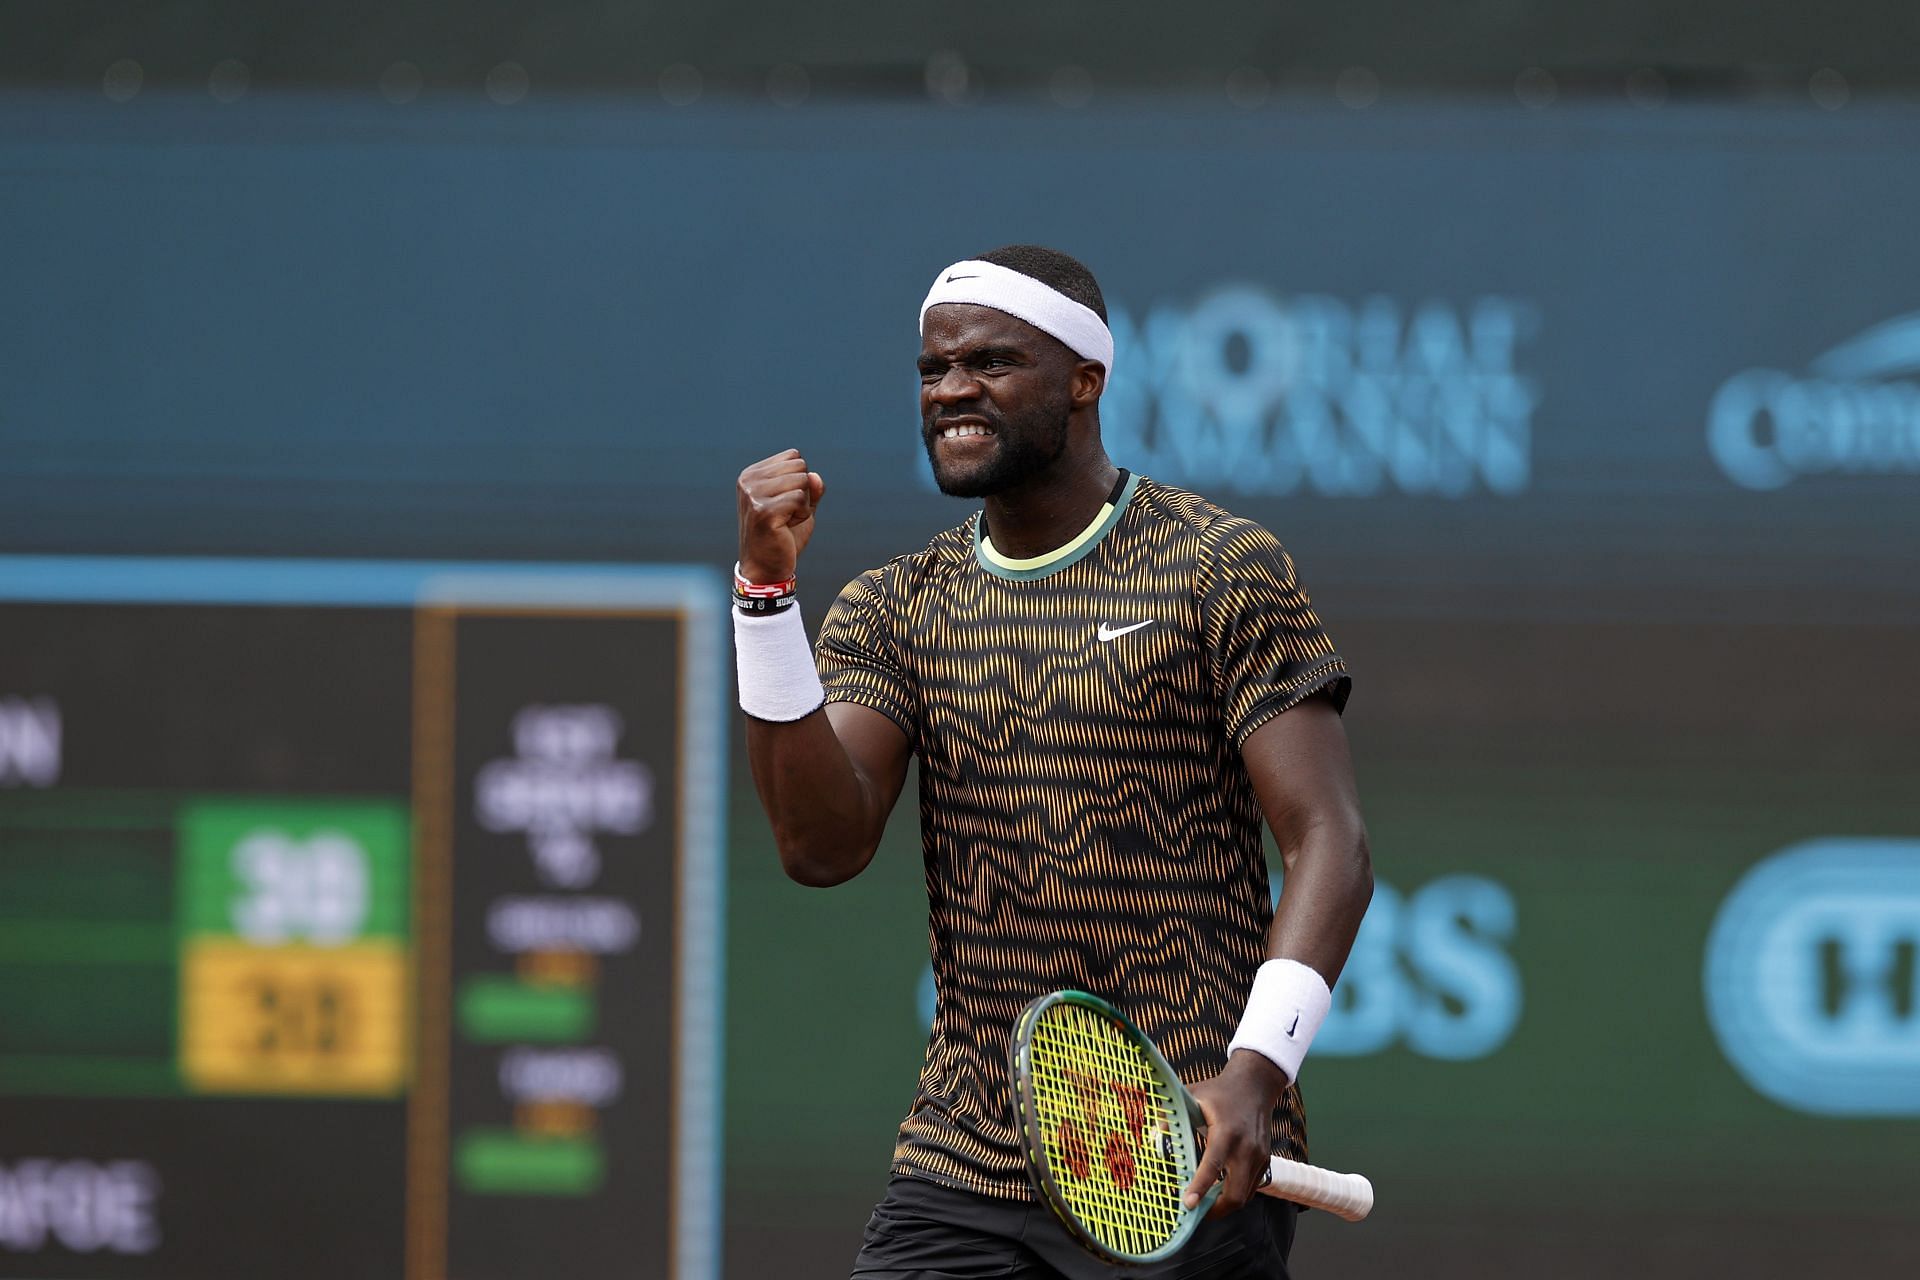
[0,1159,159,1253]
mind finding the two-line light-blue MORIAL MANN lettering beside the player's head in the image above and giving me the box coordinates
[1100,286,1540,499]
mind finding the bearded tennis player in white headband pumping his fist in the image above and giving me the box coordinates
[735,246,1373,1280]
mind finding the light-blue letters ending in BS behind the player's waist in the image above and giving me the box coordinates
[916,875,1521,1061]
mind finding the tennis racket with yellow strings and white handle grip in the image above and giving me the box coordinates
[1012,990,1373,1265]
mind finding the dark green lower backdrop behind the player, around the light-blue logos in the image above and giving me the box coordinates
[728,614,1920,1280]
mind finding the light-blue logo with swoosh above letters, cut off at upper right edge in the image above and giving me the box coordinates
[1707,311,1920,489]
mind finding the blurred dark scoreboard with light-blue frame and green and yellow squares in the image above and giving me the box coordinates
[0,558,726,1280]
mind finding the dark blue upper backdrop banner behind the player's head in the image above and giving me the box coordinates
[0,94,1920,620]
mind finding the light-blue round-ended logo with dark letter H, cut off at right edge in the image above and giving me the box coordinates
[1705,837,1920,1115]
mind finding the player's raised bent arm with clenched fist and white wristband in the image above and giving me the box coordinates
[735,449,908,887]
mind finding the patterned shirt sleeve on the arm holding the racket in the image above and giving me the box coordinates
[1196,518,1354,747]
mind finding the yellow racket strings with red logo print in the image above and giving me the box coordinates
[1029,1004,1192,1257]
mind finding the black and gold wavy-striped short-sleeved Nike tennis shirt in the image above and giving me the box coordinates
[816,472,1350,1197]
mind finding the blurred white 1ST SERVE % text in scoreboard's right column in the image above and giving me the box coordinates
[474,704,653,889]
